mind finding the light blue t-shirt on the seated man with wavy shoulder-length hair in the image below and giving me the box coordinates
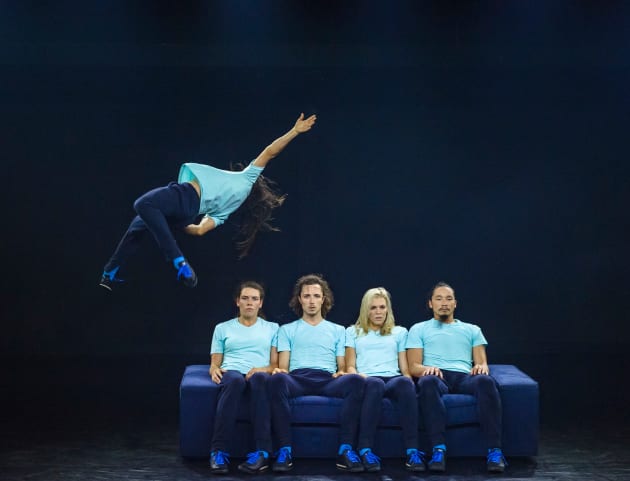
[278,319,346,373]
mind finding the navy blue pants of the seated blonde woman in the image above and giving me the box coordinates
[357,376,418,449]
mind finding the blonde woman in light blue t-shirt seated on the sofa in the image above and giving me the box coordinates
[346,287,426,472]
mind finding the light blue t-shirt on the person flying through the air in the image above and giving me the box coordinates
[177,161,264,226]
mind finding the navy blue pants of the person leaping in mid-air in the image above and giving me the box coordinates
[105,182,200,272]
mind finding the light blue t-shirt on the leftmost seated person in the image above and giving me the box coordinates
[210,317,279,374]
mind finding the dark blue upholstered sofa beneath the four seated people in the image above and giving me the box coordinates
[179,364,538,458]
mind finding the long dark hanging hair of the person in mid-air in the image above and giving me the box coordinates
[231,164,287,259]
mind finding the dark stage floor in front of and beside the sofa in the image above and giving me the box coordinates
[0,424,630,481]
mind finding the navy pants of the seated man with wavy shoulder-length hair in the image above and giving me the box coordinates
[267,369,365,447]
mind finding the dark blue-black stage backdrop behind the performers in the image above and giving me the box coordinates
[0,1,630,424]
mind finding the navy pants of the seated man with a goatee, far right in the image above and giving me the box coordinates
[417,370,503,448]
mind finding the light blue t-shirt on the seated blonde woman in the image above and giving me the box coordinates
[346,326,407,377]
